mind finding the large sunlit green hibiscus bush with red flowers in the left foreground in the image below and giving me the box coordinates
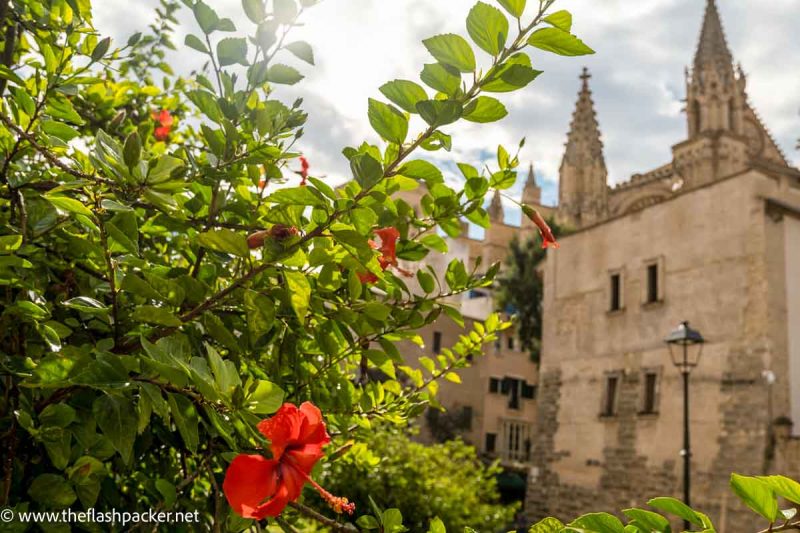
[0,0,591,531]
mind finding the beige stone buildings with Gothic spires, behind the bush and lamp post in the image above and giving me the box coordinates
[406,0,800,533]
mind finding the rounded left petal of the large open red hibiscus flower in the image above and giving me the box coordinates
[222,454,278,518]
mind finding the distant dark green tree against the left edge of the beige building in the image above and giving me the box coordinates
[496,219,564,362]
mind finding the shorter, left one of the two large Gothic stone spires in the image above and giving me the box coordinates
[558,68,608,227]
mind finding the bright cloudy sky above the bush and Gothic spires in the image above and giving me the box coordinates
[93,0,800,217]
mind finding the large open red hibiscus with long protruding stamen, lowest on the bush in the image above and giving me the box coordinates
[222,402,355,520]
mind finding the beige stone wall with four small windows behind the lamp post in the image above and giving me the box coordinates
[527,171,800,531]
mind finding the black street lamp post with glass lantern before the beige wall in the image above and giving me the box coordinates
[664,320,705,530]
